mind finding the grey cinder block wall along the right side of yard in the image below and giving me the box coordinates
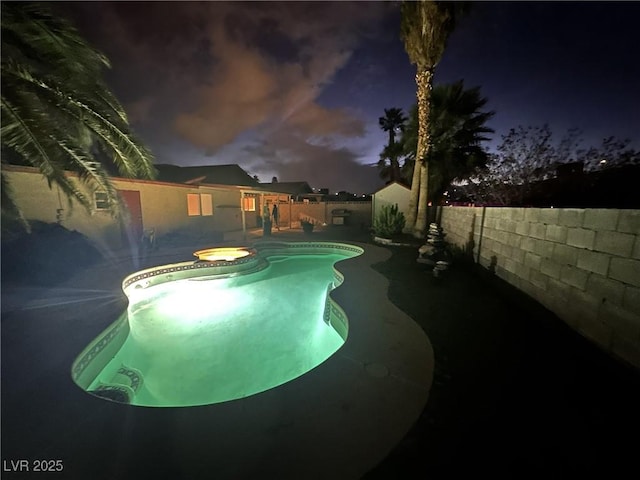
[438,207,640,368]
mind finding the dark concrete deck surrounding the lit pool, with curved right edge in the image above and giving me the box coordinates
[2,229,434,479]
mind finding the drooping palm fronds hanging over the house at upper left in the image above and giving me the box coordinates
[0,2,155,228]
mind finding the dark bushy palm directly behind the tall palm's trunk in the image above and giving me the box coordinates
[401,80,494,204]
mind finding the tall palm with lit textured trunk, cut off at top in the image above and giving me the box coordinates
[400,0,468,238]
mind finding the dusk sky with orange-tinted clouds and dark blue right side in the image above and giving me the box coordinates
[55,1,640,194]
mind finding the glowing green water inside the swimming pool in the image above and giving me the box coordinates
[81,253,355,406]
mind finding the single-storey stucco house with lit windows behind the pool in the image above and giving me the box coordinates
[2,165,290,255]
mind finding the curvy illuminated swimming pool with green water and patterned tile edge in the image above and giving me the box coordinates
[72,242,363,407]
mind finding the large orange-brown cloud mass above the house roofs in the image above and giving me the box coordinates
[61,2,390,191]
